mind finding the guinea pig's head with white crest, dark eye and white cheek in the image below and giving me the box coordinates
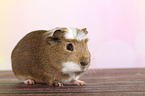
[46,27,90,73]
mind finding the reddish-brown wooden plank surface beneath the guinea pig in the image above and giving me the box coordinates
[0,69,145,96]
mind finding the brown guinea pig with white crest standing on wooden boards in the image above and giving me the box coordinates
[11,27,90,87]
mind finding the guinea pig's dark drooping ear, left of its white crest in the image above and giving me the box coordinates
[46,30,64,45]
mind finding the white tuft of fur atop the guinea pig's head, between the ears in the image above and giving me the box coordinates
[65,27,87,41]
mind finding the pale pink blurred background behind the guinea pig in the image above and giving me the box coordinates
[0,0,145,70]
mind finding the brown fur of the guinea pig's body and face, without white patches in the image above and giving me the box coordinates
[11,28,90,85]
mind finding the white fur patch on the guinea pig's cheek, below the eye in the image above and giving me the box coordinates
[62,62,81,74]
